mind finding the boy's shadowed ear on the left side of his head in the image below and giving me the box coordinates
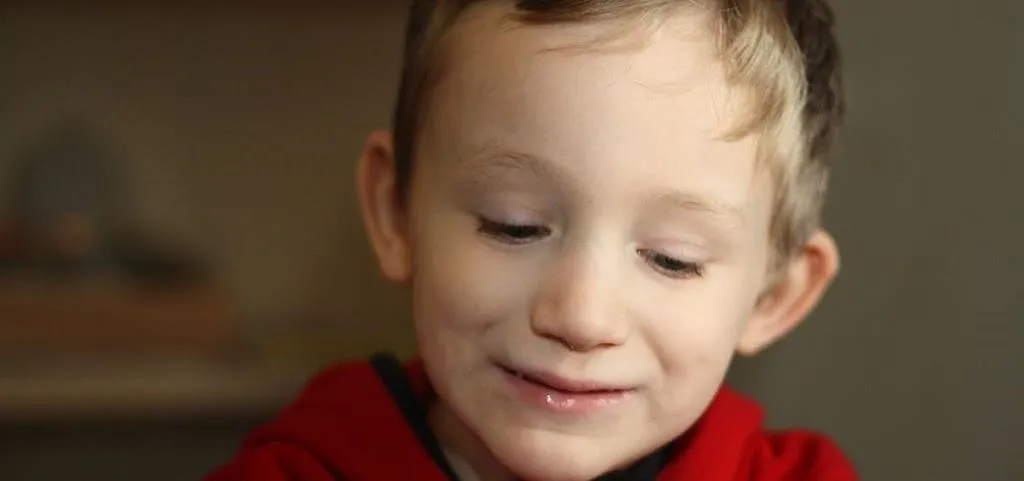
[355,131,412,283]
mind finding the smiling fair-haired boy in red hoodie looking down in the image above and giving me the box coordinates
[209,0,855,481]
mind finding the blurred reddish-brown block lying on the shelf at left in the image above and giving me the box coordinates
[0,278,239,353]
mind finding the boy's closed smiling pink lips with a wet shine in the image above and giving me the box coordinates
[501,369,633,414]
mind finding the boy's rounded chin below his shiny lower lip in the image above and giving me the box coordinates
[485,423,625,481]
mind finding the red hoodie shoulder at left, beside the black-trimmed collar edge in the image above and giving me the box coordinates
[207,356,437,481]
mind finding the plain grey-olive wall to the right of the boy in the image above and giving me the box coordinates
[742,0,1024,480]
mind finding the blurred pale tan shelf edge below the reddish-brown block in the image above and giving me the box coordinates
[0,358,310,423]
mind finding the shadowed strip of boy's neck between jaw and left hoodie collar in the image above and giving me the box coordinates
[428,400,515,481]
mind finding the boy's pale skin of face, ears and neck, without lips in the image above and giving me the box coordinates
[357,2,838,480]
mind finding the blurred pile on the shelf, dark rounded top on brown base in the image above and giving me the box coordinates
[0,122,234,355]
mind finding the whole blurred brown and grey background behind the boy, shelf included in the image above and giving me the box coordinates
[0,0,1024,481]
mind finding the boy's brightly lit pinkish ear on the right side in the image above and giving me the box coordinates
[736,230,839,356]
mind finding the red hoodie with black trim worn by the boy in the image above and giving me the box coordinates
[206,357,857,481]
